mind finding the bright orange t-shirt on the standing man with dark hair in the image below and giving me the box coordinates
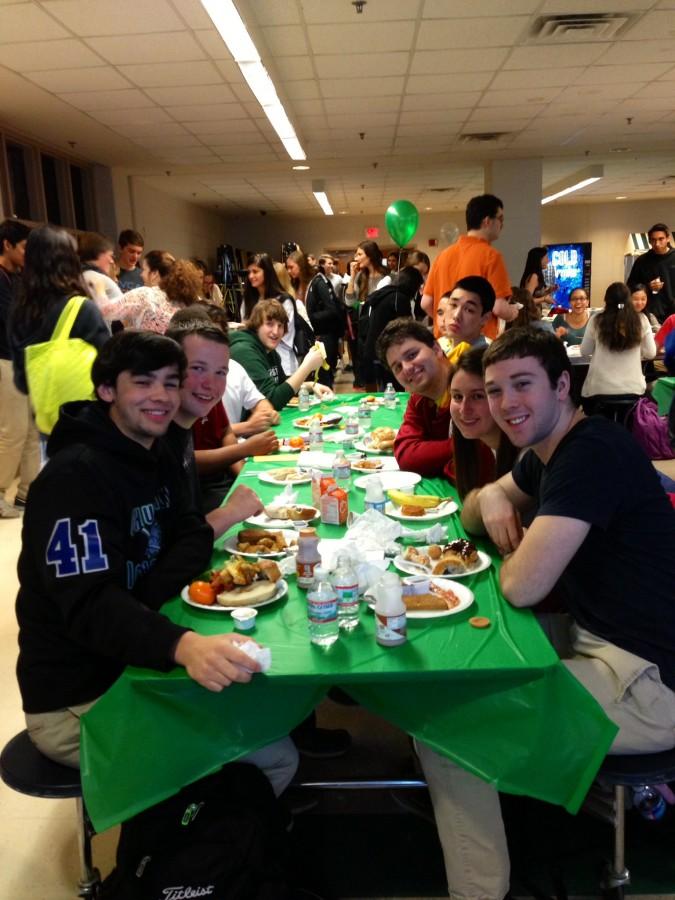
[424,234,511,337]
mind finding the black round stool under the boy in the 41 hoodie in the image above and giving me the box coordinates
[0,731,101,897]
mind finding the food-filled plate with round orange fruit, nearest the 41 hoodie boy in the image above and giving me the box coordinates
[181,556,288,612]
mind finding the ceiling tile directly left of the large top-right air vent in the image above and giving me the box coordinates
[415,16,528,50]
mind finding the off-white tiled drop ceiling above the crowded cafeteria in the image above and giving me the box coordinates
[0,0,675,217]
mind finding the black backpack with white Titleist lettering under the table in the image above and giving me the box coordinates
[98,763,288,900]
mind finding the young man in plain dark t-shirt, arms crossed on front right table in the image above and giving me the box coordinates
[418,328,675,898]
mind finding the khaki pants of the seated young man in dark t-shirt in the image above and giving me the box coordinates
[416,624,675,900]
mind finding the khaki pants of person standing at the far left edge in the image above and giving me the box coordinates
[0,359,40,500]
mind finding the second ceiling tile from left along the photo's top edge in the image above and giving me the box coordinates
[42,0,183,36]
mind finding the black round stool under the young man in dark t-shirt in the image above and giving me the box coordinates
[586,749,675,900]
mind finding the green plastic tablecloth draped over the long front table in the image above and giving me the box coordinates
[82,396,616,830]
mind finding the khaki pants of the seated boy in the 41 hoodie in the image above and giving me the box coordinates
[26,700,298,797]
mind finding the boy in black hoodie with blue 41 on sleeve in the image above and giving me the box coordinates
[16,332,294,792]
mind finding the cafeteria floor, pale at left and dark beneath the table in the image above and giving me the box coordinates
[0,362,675,900]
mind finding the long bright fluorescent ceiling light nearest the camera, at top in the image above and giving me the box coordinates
[201,0,307,159]
